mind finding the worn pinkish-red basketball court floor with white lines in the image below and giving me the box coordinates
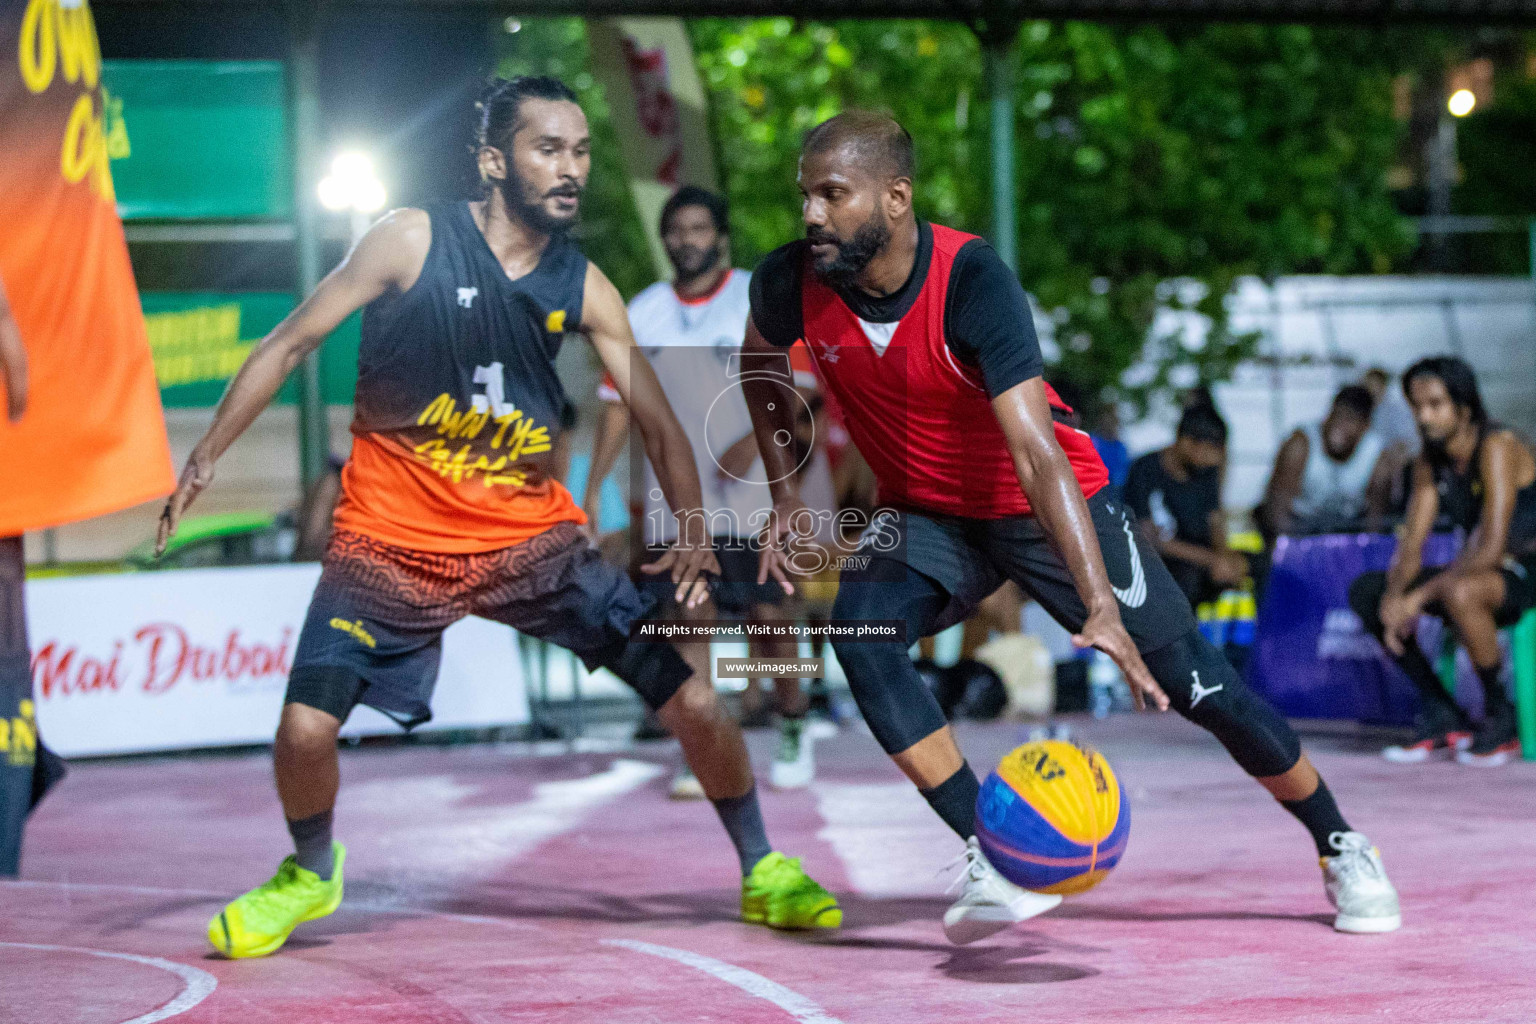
[0,715,1536,1024]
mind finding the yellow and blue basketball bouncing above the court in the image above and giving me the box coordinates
[975,740,1130,895]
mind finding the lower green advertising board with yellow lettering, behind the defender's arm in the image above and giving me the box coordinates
[140,292,362,408]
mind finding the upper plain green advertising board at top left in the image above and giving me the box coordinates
[101,60,293,221]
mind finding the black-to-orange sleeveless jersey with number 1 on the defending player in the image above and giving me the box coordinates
[336,203,587,553]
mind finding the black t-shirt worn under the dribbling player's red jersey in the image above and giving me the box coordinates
[751,221,1044,398]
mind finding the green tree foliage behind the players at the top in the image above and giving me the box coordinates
[505,18,1409,408]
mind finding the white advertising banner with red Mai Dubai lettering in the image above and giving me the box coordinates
[26,565,528,757]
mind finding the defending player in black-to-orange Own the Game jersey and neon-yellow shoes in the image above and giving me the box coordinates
[160,78,842,956]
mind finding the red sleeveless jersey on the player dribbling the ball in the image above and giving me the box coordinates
[800,224,1109,519]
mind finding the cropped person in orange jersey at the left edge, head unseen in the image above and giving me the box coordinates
[0,0,175,877]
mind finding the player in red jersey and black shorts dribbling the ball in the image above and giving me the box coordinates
[742,112,1401,943]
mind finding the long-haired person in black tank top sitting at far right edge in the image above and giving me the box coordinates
[1350,356,1536,765]
